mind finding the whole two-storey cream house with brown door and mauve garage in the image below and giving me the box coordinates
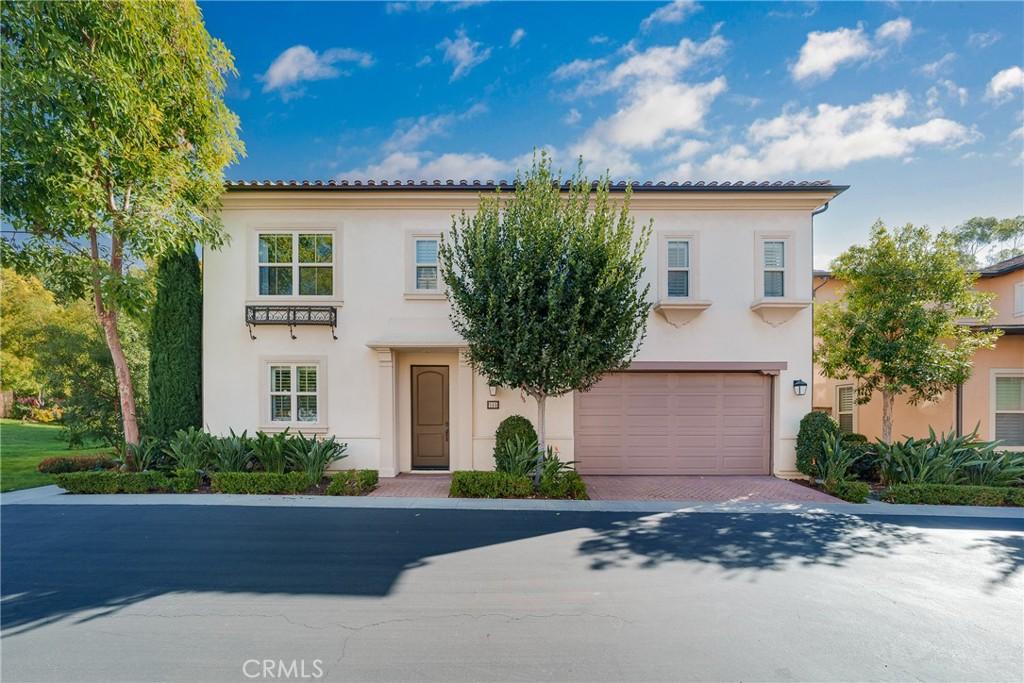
[203,181,845,476]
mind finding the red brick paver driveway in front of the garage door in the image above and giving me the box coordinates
[584,474,842,503]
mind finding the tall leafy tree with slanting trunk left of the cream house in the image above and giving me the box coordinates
[0,0,243,443]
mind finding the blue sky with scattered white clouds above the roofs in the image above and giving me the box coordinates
[202,2,1024,266]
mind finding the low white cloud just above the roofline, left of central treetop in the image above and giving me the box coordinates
[335,152,513,180]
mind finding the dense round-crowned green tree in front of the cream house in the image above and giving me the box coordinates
[440,155,650,481]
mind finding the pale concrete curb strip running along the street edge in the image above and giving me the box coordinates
[0,485,1024,521]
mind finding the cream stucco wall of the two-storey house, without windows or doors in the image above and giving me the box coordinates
[203,187,827,475]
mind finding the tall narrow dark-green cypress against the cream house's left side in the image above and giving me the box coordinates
[148,248,203,438]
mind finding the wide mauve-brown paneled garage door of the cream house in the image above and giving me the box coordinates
[573,373,771,474]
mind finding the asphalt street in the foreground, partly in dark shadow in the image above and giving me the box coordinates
[0,505,1024,683]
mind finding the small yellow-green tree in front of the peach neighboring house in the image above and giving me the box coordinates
[814,221,999,443]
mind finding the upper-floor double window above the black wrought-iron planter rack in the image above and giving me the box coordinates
[257,232,334,296]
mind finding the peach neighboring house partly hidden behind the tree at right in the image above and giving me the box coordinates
[814,256,1024,451]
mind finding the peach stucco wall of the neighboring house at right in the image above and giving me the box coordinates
[813,270,1024,440]
